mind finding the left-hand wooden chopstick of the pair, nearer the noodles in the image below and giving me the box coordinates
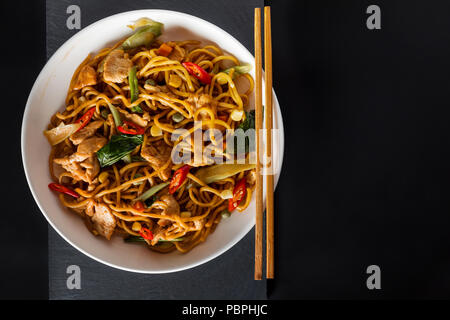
[255,8,263,280]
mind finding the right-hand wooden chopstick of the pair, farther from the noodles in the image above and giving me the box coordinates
[264,6,274,279]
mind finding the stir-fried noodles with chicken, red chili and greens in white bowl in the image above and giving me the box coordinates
[44,19,255,252]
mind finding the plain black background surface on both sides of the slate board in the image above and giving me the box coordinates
[4,0,450,299]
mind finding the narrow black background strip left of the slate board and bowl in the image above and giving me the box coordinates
[0,0,48,299]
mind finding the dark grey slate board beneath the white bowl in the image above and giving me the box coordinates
[46,0,266,300]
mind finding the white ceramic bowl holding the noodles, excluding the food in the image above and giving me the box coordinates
[22,10,284,273]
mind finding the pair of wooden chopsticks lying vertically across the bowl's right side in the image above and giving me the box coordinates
[255,6,274,280]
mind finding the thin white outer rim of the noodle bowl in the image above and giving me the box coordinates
[21,9,285,274]
